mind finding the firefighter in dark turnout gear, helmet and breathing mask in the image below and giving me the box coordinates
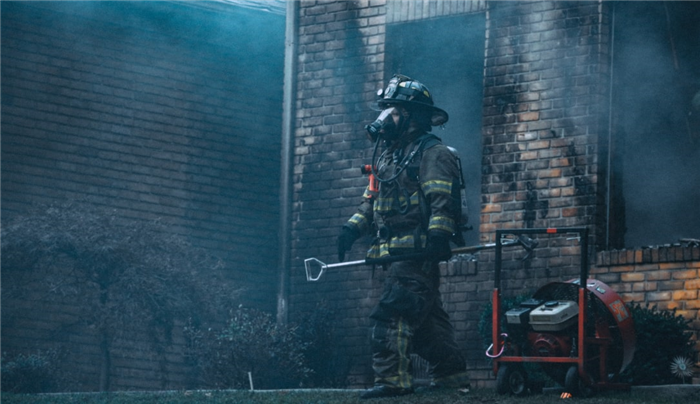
[338,74,469,398]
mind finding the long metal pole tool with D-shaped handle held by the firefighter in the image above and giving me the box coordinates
[304,235,538,282]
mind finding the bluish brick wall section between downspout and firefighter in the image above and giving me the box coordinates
[290,0,386,385]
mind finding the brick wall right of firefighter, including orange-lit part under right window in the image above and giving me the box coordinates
[468,1,700,384]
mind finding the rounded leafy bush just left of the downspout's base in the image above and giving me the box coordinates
[195,307,311,389]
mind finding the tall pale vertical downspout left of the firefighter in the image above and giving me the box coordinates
[277,0,299,324]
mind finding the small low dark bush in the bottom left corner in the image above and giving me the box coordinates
[0,350,57,393]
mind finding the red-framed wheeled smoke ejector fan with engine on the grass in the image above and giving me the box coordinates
[487,228,636,396]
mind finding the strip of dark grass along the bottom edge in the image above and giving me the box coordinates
[0,388,688,404]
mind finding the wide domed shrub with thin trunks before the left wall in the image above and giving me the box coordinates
[0,203,235,391]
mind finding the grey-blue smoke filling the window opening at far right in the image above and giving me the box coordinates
[613,0,700,247]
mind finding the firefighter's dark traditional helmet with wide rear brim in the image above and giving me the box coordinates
[377,74,449,126]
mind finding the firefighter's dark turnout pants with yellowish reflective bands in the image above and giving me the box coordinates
[370,261,469,388]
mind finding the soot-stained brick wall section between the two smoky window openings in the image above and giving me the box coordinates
[456,0,608,383]
